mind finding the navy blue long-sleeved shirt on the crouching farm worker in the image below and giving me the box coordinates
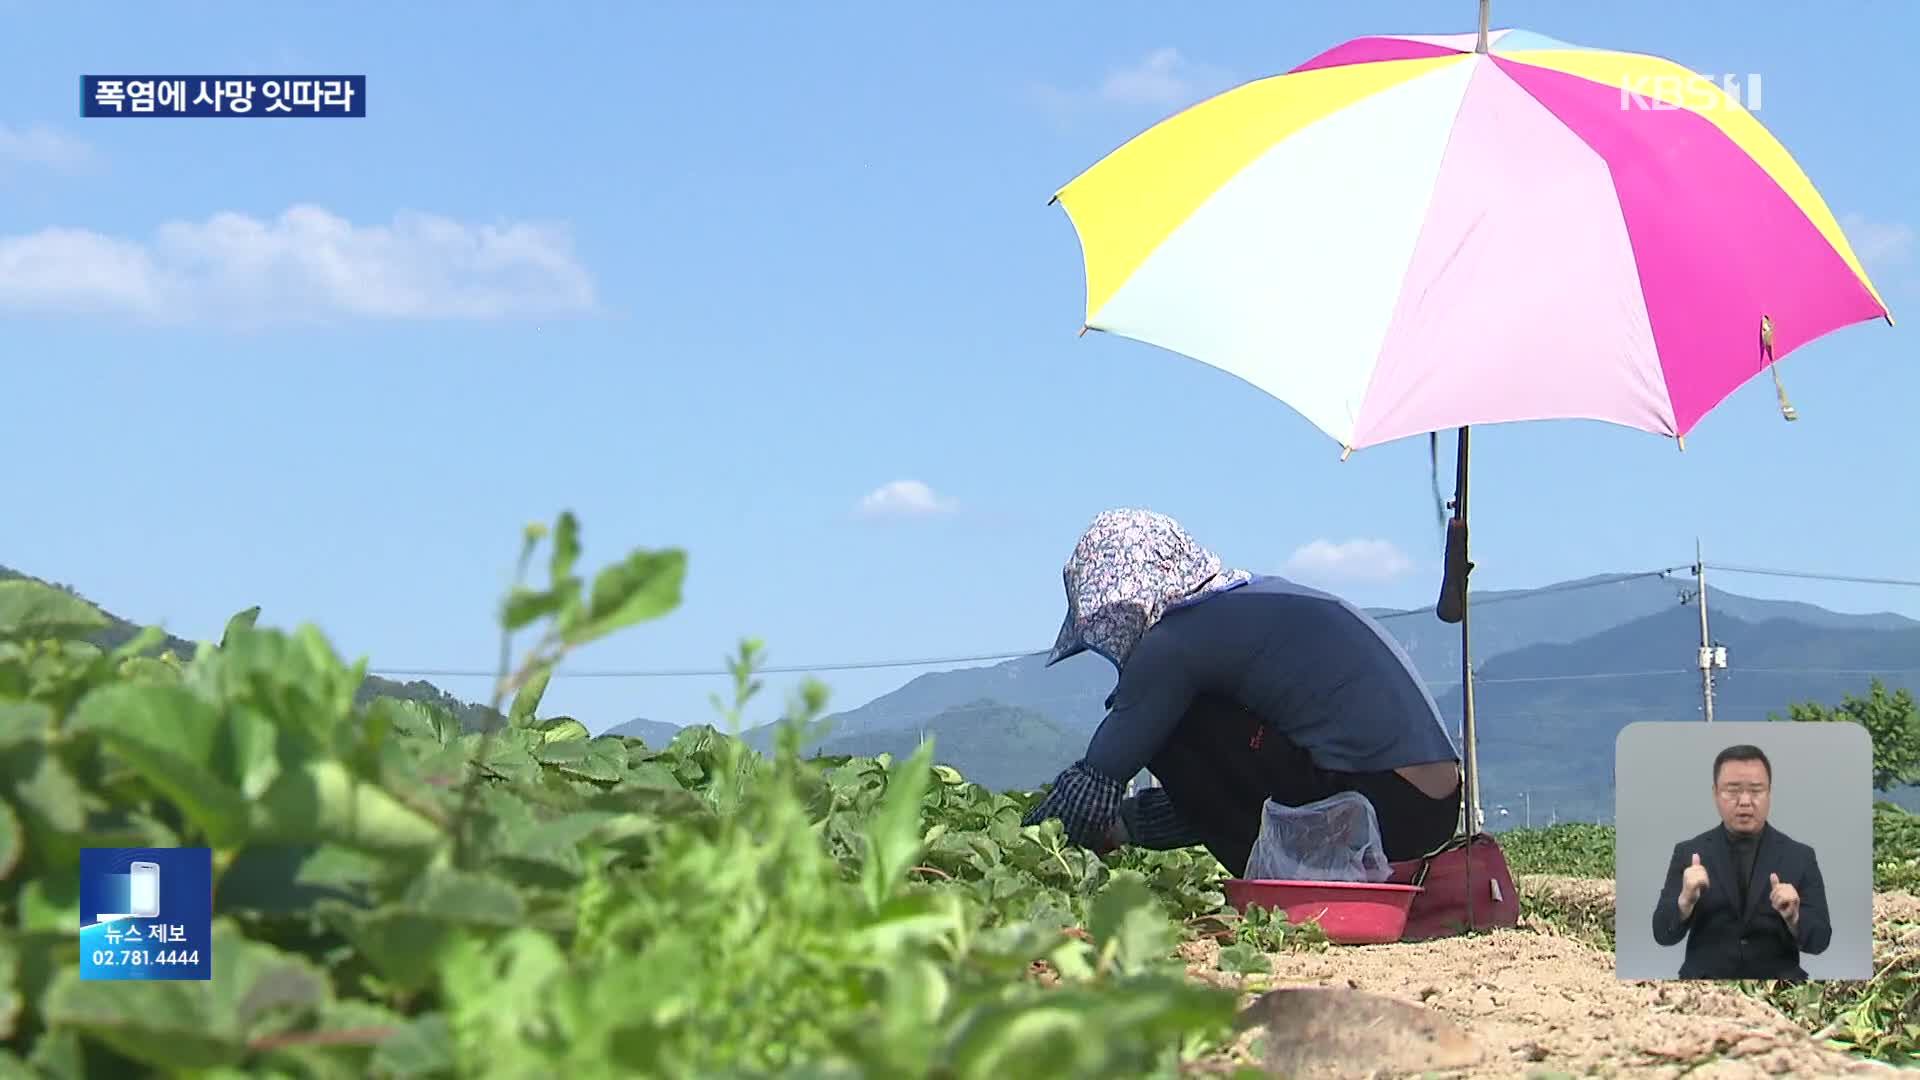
[1085,577,1459,784]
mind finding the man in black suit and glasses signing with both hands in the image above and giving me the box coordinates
[1653,746,1834,982]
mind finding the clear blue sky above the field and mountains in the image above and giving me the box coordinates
[0,0,1920,728]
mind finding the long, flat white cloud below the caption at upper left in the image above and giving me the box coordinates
[0,206,593,325]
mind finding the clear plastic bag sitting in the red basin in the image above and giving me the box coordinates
[1246,792,1394,882]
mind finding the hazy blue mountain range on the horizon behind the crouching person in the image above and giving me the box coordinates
[15,553,1920,828]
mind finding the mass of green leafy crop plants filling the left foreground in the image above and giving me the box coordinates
[0,515,1235,1078]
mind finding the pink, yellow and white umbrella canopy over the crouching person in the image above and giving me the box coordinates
[1054,31,1891,450]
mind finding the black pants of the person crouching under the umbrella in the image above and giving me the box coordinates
[1148,698,1461,876]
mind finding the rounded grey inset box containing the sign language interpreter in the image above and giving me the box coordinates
[1613,721,1874,980]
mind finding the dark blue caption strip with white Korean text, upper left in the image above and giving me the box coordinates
[81,75,367,117]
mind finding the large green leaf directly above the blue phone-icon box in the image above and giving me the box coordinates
[71,684,261,847]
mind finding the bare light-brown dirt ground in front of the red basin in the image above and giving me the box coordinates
[1185,878,1920,1080]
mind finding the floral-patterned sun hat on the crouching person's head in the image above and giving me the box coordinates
[1046,509,1252,667]
